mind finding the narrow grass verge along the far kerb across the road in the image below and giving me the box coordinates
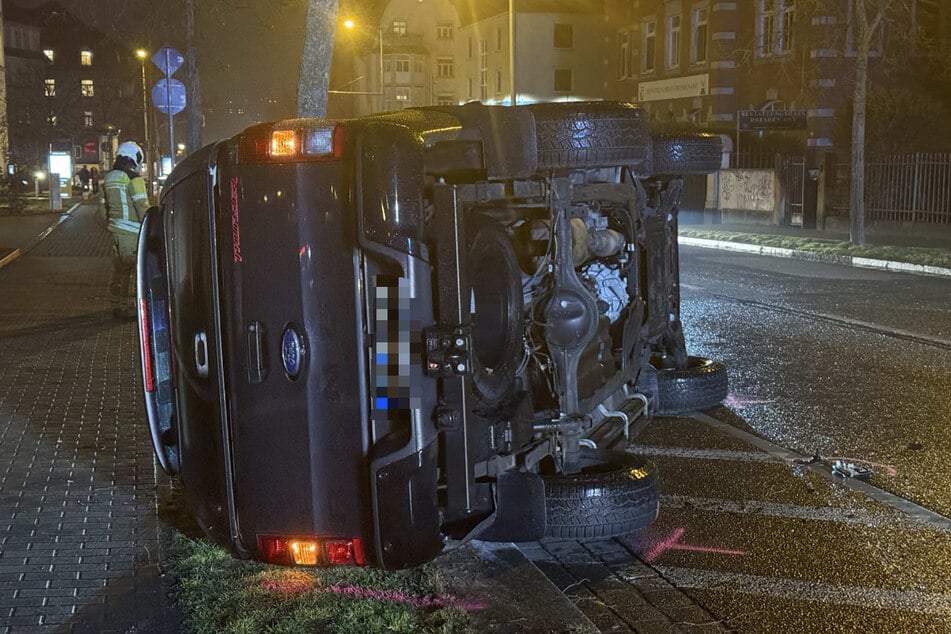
[679,227,951,268]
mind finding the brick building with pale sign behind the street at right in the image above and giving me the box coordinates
[606,0,951,163]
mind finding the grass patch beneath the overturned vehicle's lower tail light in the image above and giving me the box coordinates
[167,534,478,634]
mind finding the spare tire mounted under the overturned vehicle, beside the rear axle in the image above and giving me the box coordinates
[467,216,525,407]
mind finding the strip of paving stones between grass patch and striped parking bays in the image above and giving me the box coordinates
[518,539,728,634]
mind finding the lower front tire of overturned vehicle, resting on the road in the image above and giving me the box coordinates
[654,356,729,416]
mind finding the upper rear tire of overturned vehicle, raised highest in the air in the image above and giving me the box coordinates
[528,101,651,173]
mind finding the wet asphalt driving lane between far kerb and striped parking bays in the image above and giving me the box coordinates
[681,248,951,516]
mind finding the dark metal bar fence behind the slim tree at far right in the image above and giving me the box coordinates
[828,153,951,225]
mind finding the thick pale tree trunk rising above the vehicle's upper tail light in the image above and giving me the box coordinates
[297,0,337,117]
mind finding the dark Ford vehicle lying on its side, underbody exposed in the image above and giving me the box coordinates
[138,102,727,568]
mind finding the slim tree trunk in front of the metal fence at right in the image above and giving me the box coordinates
[849,0,872,245]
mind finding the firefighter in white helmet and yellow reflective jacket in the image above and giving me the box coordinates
[99,141,149,319]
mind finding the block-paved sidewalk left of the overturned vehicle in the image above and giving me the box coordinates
[0,205,178,632]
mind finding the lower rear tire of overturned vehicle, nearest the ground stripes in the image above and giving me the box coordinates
[542,447,659,539]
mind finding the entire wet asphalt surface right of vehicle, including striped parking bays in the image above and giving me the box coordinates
[624,248,951,632]
